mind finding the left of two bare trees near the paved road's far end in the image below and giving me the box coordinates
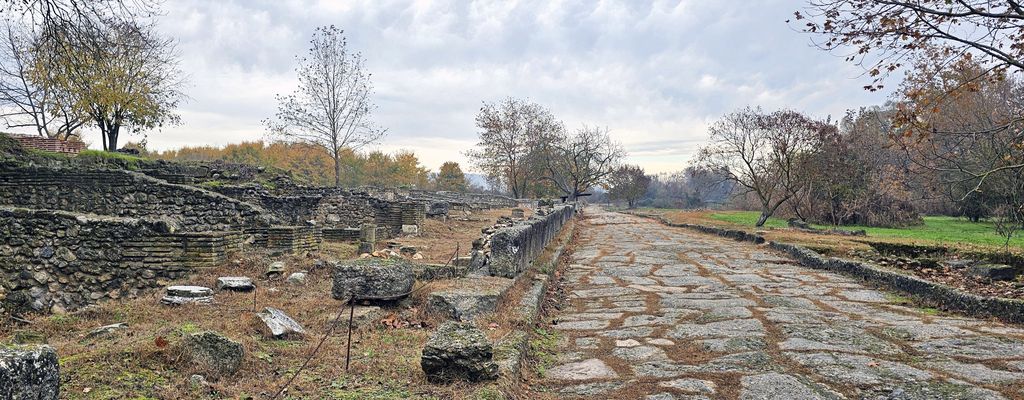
[466,97,564,197]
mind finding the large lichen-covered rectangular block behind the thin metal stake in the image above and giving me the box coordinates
[331,259,416,301]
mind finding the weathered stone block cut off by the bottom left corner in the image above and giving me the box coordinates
[0,345,60,400]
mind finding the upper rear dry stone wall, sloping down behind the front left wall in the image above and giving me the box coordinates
[0,164,272,232]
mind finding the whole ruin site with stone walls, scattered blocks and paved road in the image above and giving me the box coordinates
[0,135,1024,399]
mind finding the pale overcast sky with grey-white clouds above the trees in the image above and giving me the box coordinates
[144,0,885,172]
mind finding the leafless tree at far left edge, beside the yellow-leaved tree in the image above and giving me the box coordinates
[0,20,89,139]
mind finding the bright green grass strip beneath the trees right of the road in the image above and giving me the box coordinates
[710,211,1024,249]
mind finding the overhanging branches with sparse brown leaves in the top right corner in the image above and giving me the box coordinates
[796,0,1024,90]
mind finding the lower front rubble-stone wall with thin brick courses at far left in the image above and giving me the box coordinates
[0,207,244,314]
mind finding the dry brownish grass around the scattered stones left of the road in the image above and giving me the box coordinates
[0,210,528,399]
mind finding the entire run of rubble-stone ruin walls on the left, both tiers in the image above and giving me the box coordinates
[0,158,543,314]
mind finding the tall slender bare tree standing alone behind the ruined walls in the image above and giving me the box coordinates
[263,26,386,186]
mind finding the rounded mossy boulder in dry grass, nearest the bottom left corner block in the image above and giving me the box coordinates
[182,330,245,377]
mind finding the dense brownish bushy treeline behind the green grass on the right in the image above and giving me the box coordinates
[696,59,1024,234]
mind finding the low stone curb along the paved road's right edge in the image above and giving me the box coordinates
[629,213,1024,323]
